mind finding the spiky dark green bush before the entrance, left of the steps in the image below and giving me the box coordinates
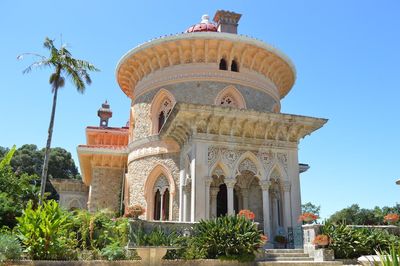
[191,216,263,261]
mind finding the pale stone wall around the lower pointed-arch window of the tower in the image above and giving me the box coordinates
[127,153,179,220]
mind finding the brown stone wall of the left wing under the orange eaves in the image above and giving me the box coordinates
[88,167,124,211]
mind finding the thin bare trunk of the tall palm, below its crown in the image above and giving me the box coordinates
[39,86,58,205]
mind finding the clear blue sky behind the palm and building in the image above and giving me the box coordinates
[0,0,400,217]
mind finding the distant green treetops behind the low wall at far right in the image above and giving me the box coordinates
[328,204,400,225]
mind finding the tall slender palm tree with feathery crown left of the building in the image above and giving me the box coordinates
[18,37,99,204]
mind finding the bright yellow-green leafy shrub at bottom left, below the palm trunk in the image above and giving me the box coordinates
[16,201,77,260]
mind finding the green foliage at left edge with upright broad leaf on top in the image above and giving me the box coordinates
[0,147,38,228]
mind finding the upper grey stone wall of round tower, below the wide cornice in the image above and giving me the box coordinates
[132,81,276,139]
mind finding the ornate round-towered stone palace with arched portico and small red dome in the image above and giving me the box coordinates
[56,10,327,241]
